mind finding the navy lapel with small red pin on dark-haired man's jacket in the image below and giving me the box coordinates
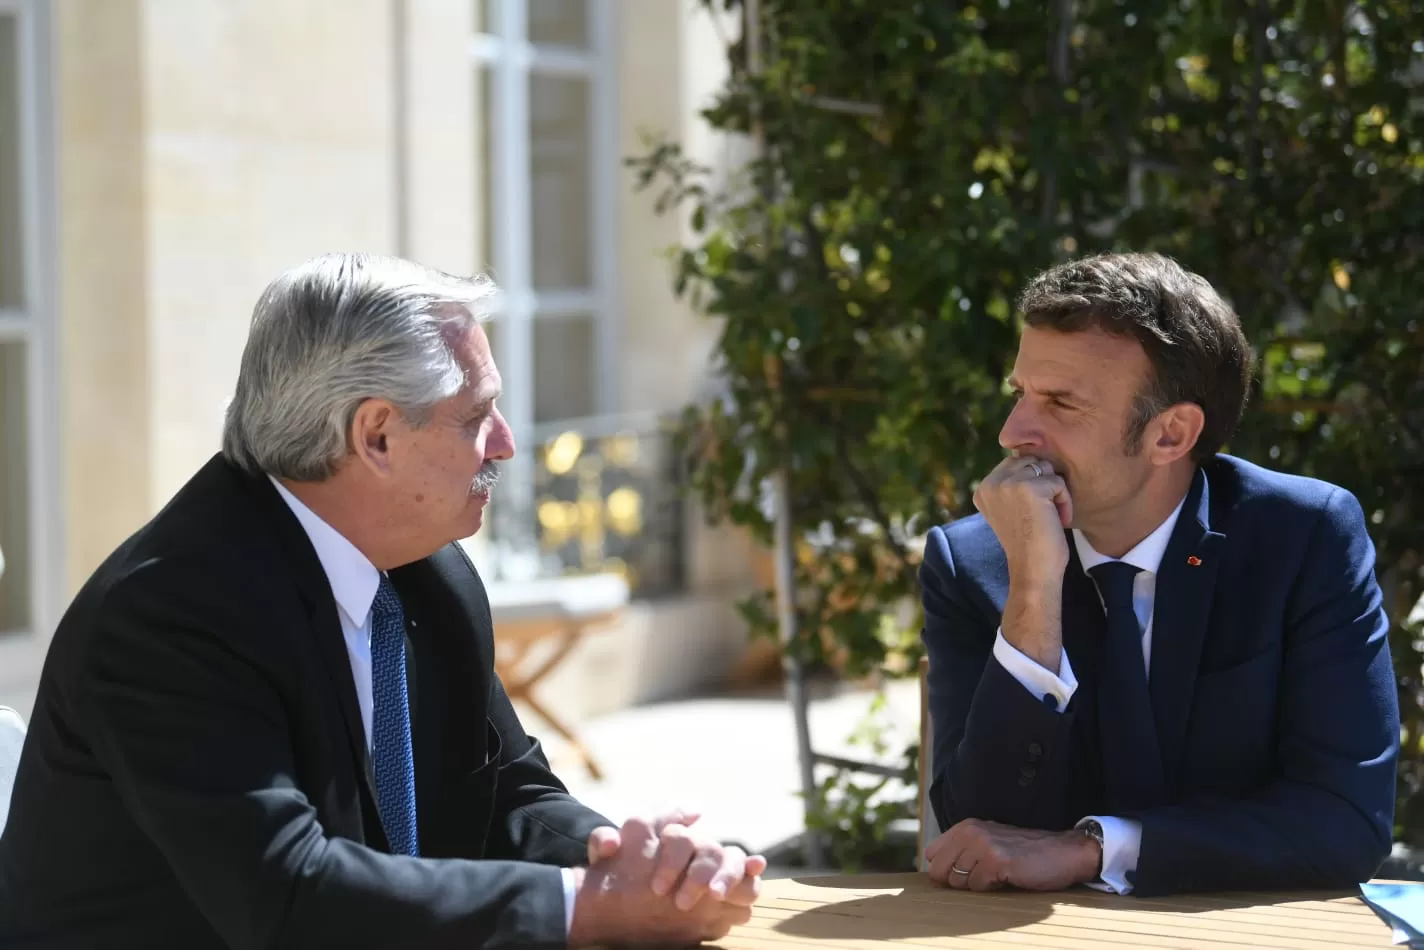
[1149,469,1226,792]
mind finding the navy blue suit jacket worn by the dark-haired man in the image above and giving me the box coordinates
[920,456,1400,894]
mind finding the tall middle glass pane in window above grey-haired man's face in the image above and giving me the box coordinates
[530,74,594,291]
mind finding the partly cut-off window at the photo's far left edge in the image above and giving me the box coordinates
[0,0,57,635]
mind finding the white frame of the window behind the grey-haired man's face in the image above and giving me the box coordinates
[470,0,622,575]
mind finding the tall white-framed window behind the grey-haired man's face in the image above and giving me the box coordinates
[471,0,621,575]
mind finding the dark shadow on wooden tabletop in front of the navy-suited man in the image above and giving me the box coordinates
[773,876,1341,940]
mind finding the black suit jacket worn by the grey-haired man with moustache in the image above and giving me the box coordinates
[0,457,608,950]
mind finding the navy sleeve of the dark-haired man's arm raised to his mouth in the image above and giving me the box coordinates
[920,528,1079,829]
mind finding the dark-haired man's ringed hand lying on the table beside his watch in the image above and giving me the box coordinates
[924,818,1102,890]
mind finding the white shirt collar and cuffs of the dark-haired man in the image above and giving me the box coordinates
[994,497,1186,894]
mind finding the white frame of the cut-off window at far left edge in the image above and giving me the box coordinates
[0,0,64,638]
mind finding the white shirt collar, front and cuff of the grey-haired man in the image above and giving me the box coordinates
[268,476,575,933]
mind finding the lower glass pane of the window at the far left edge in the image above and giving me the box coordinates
[0,343,31,632]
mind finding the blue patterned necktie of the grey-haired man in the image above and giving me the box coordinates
[370,574,420,856]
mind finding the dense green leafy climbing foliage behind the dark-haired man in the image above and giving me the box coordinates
[632,0,1424,860]
